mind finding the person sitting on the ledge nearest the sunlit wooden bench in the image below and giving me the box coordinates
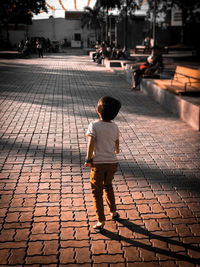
[132,45,163,90]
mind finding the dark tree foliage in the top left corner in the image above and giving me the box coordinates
[0,0,47,25]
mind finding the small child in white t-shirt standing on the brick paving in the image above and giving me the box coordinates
[85,96,121,230]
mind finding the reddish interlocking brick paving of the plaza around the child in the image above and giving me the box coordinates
[0,51,200,267]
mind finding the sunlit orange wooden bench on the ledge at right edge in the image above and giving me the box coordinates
[152,66,200,95]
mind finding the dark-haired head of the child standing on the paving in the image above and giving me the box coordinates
[97,96,121,121]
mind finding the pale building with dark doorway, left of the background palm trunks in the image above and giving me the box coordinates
[9,11,95,47]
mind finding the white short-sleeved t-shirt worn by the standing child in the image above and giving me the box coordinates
[86,120,119,164]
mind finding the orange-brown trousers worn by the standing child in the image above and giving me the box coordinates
[90,163,118,222]
